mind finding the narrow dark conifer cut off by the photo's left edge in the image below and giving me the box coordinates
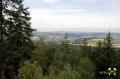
[0,0,12,79]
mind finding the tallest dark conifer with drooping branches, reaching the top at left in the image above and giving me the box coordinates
[0,0,33,79]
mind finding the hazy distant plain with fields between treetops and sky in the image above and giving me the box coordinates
[33,31,120,45]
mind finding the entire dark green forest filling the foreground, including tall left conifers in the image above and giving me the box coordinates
[0,0,120,79]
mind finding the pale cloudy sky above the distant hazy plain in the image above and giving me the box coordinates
[24,0,120,32]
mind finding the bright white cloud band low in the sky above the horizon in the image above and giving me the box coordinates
[31,10,120,29]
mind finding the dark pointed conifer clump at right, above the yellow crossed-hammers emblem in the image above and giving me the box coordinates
[91,33,115,67]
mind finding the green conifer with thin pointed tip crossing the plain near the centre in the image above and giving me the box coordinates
[52,33,71,72]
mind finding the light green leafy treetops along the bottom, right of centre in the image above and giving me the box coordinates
[48,58,95,79]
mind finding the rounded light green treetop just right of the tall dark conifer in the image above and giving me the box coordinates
[32,40,49,72]
